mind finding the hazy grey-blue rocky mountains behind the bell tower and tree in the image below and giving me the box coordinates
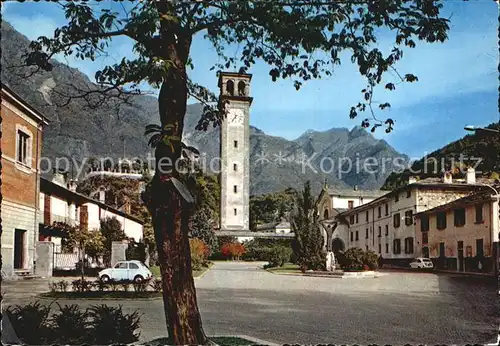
[1,21,407,194]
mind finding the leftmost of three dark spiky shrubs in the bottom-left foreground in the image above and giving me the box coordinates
[5,301,52,345]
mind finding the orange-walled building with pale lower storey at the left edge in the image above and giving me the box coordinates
[1,84,48,277]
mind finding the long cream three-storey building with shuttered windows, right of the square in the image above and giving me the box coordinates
[337,176,480,266]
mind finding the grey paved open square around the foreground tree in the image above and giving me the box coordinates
[2,262,500,345]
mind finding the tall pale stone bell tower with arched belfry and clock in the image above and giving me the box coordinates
[219,72,252,232]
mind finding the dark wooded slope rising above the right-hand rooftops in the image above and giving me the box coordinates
[382,124,500,190]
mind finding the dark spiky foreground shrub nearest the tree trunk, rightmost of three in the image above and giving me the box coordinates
[88,304,140,345]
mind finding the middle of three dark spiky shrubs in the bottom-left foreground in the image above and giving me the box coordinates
[51,303,88,345]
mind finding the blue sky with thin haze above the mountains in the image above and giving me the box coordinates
[2,0,499,157]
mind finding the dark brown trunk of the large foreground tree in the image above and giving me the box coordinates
[144,33,208,345]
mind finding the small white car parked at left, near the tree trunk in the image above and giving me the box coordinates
[98,261,153,283]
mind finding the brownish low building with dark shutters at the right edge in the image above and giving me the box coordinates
[416,191,500,273]
